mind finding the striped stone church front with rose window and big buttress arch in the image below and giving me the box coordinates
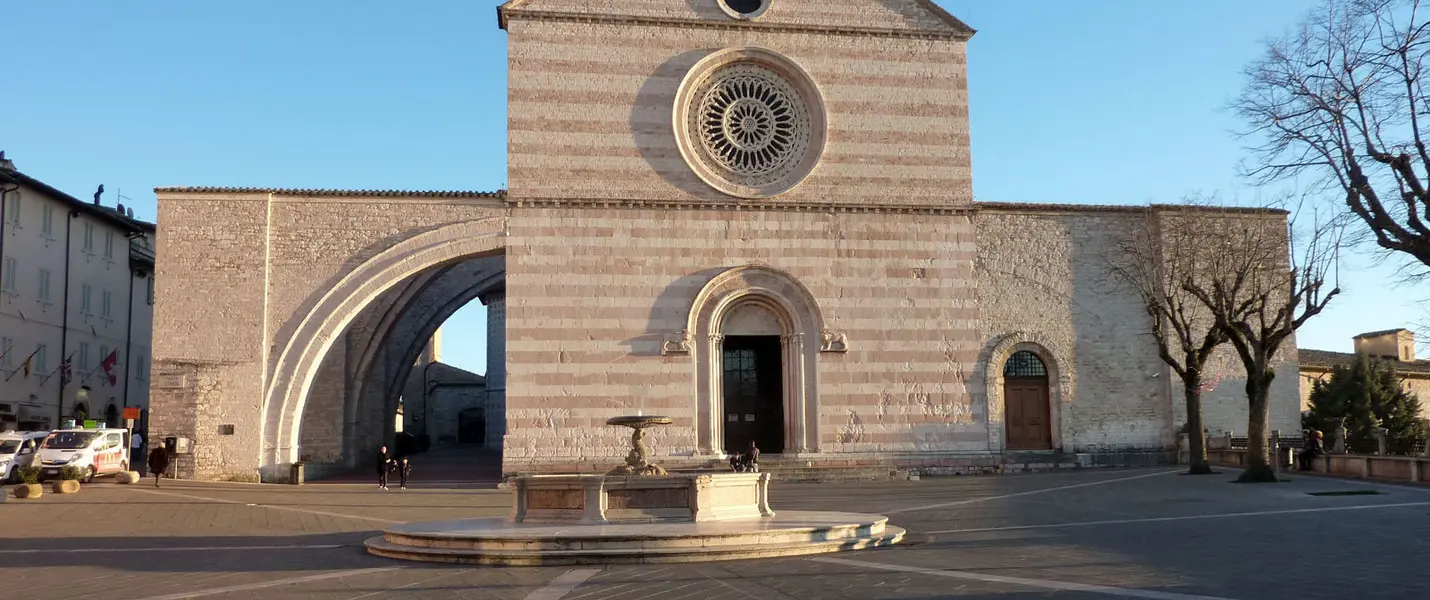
[152,0,1298,480]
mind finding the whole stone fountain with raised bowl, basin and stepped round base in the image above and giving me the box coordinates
[365,414,904,564]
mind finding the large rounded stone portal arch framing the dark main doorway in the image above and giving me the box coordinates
[685,264,824,456]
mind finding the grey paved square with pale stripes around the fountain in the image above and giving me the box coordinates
[0,469,1430,600]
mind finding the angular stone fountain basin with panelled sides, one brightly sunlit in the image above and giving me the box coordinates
[511,473,775,524]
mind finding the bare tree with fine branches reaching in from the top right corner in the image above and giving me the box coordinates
[1231,0,1430,271]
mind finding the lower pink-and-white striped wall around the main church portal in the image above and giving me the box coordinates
[503,209,987,467]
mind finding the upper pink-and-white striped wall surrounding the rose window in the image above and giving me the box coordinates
[508,16,972,206]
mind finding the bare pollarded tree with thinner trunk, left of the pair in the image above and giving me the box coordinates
[1105,200,1246,474]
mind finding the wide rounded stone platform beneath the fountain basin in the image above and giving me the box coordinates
[366,511,904,566]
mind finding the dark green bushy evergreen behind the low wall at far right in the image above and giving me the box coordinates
[1301,354,1427,454]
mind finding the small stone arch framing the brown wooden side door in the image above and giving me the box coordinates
[982,331,1073,451]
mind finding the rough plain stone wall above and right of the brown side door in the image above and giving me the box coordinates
[977,204,1175,451]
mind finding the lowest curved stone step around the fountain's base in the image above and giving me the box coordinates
[365,527,905,567]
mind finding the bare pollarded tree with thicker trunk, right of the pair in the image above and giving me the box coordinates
[1183,205,1343,481]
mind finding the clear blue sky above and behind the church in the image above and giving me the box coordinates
[0,0,1430,373]
